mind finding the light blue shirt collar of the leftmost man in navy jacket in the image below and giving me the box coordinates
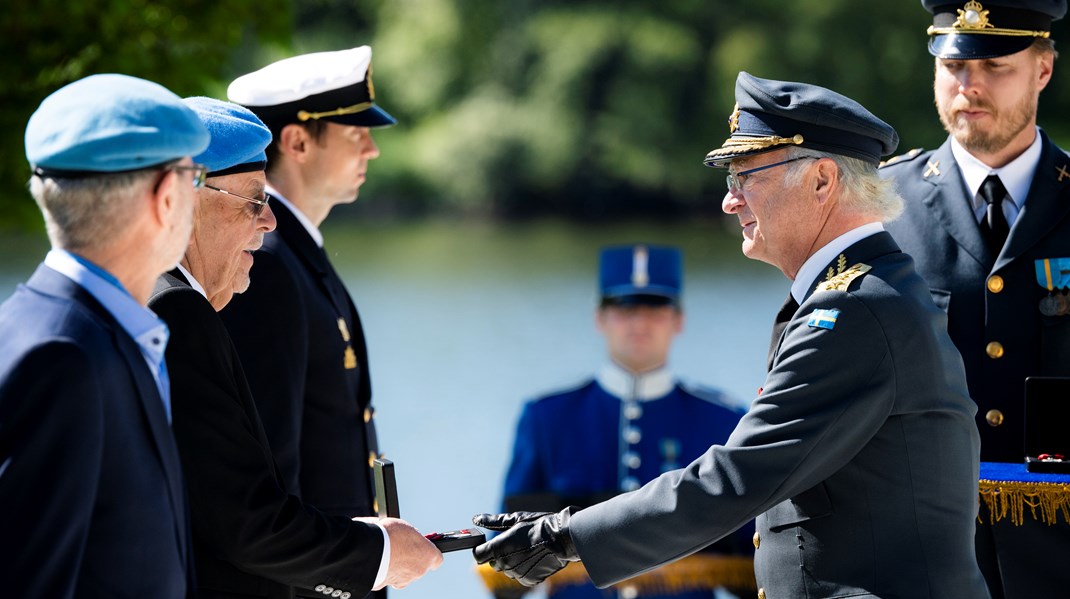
[45,249,171,423]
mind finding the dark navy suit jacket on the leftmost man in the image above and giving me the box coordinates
[0,266,194,599]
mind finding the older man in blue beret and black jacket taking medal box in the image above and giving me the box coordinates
[149,97,442,599]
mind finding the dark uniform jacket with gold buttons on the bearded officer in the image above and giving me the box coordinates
[881,134,1070,462]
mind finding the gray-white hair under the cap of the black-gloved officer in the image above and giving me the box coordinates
[784,147,903,220]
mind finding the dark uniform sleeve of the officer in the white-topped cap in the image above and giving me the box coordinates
[219,251,309,496]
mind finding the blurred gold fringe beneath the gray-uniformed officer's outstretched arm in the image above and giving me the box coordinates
[476,554,758,597]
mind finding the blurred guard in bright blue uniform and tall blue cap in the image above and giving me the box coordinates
[492,245,753,599]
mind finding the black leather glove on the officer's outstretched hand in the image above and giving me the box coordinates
[472,506,580,586]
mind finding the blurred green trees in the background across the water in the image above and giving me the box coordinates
[0,0,1070,228]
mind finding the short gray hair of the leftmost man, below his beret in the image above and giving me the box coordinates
[30,169,159,250]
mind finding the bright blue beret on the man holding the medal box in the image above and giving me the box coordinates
[182,96,271,176]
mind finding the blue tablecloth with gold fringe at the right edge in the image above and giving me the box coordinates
[978,462,1070,525]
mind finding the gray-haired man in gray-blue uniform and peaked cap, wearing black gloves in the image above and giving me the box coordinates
[475,73,988,599]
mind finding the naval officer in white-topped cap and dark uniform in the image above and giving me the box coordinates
[221,46,396,526]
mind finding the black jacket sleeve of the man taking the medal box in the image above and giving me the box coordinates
[150,288,383,597]
